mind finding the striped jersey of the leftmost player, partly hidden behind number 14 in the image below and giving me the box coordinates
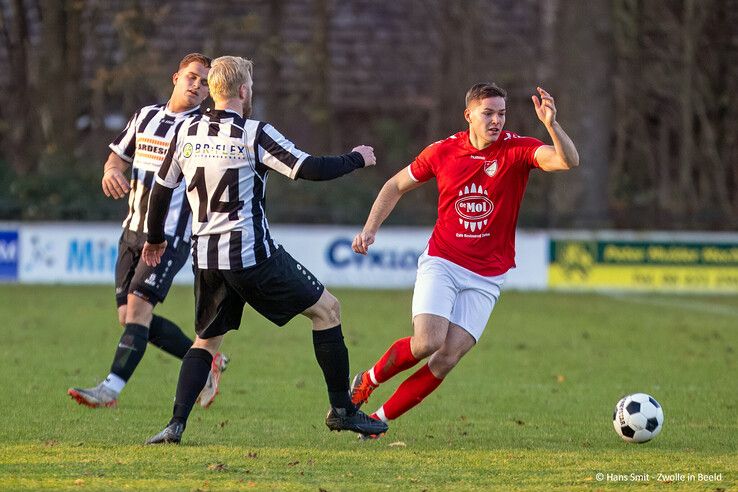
[110,104,200,241]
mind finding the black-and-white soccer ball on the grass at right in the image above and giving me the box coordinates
[612,393,664,443]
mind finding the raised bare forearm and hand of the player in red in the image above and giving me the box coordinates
[531,87,579,171]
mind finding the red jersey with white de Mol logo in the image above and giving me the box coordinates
[407,130,544,277]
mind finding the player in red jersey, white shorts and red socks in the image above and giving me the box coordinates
[351,84,579,437]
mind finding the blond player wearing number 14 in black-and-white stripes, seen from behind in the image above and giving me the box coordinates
[142,56,387,444]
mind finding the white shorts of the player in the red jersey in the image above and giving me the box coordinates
[413,250,506,341]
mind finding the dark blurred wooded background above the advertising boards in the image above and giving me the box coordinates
[0,0,738,230]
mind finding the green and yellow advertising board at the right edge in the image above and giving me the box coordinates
[548,239,738,293]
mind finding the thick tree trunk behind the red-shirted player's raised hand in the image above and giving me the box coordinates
[550,0,614,227]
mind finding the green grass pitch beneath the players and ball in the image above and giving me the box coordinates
[0,285,738,491]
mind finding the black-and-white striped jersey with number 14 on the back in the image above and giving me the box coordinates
[156,110,309,270]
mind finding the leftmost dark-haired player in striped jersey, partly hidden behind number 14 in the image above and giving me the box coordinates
[67,53,227,408]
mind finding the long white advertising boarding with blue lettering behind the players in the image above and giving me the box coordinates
[6,222,549,289]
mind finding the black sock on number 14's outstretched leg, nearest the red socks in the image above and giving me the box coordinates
[313,325,354,411]
